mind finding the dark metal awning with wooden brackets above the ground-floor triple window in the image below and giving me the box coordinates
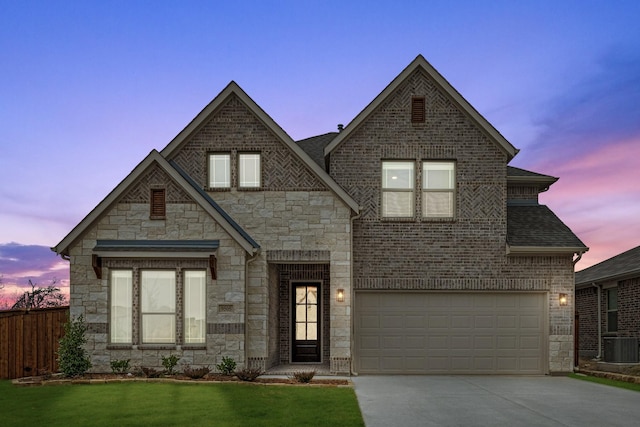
[92,240,220,280]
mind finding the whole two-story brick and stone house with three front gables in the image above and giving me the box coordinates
[53,56,587,374]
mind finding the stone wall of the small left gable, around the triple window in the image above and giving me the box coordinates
[70,196,245,372]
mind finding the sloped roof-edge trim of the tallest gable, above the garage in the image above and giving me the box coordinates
[324,54,519,161]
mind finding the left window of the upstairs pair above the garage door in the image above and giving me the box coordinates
[382,161,415,218]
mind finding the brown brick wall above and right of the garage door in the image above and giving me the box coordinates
[329,70,574,372]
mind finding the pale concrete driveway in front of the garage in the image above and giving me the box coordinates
[351,375,640,427]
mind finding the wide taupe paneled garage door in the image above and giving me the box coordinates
[355,291,547,374]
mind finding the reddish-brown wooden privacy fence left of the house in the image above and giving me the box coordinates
[0,307,69,379]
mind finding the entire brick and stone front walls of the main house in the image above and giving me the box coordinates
[58,59,574,373]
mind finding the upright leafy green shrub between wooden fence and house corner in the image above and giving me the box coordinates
[58,315,91,377]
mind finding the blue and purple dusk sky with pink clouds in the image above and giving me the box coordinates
[0,0,640,302]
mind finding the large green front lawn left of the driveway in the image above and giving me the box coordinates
[0,380,364,427]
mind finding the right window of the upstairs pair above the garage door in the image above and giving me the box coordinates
[422,161,456,218]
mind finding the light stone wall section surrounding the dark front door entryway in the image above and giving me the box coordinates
[205,190,351,372]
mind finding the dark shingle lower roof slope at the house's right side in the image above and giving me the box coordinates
[507,204,587,250]
